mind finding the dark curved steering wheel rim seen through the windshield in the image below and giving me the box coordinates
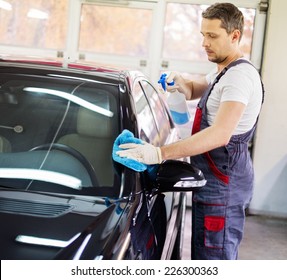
[29,143,99,186]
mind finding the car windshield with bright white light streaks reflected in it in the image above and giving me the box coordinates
[0,73,119,196]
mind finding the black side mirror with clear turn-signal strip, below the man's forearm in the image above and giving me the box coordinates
[155,160,206,192]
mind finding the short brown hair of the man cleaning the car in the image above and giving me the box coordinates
[202,3,244,41]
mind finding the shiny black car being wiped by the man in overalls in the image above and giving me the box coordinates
[0,60,205,260]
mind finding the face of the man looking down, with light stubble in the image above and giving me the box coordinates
[201,19,240,63]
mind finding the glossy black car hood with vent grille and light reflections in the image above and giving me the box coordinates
[0,190,126,260]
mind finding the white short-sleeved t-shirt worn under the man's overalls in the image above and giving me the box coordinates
[206,58,262,135]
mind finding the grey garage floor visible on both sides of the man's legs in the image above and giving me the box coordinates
[182,195,287,260]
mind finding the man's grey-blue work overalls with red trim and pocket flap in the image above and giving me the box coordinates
[191,60,264,260]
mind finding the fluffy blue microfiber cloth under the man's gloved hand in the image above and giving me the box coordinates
[112,129,158,179]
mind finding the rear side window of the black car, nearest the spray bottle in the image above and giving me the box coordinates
[141,80,171,145]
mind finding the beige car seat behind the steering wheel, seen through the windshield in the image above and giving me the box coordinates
[57,107,114,186]
